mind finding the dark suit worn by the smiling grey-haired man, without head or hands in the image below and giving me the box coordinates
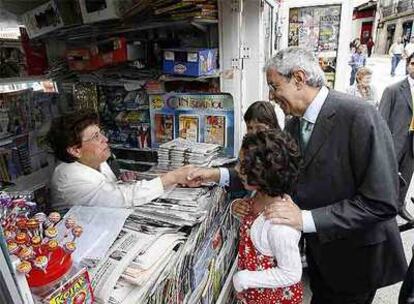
[286,91,407,293]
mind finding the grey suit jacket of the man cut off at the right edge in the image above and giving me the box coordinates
[379,79,414,163]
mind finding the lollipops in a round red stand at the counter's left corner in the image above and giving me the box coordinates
[0,192,83,287]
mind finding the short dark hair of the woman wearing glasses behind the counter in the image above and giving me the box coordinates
[46,111,99,163]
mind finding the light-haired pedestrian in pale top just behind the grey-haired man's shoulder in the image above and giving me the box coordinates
[347,67,379,108]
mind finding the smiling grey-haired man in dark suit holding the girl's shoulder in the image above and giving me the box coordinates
[266,47,407,304]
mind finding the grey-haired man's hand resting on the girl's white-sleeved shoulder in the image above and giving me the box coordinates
[264,194,303,231]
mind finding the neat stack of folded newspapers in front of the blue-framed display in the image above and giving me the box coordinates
[158,138,221,168]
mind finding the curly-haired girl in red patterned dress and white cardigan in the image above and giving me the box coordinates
[233,129,303,304]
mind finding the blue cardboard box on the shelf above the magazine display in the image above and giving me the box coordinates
[163,48,217,77]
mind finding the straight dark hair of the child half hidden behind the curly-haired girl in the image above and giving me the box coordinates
[243,100,280,129]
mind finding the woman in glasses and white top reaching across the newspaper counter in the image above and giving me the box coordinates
[47,112,191,212]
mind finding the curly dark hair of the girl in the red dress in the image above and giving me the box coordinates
[240,129,301,196]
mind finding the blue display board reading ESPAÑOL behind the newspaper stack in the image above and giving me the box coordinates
[150,93,234,156]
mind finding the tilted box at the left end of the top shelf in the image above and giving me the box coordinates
[22,0,82,38]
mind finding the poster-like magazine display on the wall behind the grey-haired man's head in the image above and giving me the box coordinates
[288,5,341,88]
